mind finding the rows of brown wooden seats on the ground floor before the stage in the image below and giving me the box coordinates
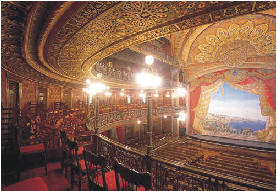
[154,140,276,185]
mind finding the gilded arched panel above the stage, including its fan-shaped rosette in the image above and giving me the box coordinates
[180,14,276,81]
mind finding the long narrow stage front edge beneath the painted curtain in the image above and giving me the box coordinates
[189,135,276,151]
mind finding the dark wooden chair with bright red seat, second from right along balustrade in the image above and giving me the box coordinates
[84,150,120,191]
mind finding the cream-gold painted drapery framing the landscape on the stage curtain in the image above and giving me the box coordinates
[192,69,276,142]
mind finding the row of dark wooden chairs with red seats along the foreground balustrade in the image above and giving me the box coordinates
[60,131,151,191]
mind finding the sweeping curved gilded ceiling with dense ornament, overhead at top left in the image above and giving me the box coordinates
[24,1,275,83]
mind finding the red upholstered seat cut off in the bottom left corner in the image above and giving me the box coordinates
[3,177,48,191]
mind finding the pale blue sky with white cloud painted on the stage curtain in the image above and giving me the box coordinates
[208,83,266,121]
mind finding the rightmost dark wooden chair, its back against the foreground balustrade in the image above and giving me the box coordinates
[114,159,151,191]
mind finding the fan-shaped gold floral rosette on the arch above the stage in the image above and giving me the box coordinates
[195,21,276,67]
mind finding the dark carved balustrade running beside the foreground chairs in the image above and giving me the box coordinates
[90,135,275,191]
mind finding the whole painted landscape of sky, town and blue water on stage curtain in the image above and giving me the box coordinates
[203,83,267,141]
